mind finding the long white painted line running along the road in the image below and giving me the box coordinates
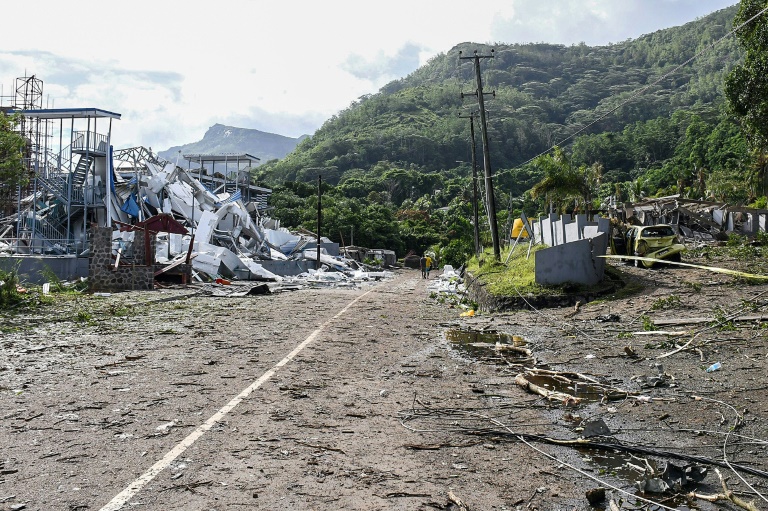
[100,289,373,511]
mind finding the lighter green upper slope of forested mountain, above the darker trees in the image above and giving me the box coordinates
[262,6,740,189]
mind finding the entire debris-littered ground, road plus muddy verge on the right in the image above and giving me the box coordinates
[0,252,768,511]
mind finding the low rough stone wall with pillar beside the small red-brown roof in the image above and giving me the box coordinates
[88,226,155,292]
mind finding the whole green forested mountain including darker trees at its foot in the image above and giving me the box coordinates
[254,6,764,266]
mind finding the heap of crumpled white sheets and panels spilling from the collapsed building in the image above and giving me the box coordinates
[0,142,392,288]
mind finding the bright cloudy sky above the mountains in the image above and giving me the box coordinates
[0,0,738,151]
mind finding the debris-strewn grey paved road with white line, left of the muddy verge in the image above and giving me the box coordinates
[0,270,560,511]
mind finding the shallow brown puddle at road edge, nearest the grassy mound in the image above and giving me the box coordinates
[445,329,529,364]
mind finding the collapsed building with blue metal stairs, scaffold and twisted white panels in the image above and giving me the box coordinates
[0,76,384,290]
